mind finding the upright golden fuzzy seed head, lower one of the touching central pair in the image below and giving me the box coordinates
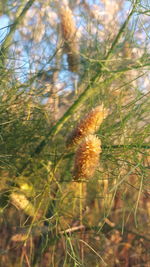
[74,135,101,180]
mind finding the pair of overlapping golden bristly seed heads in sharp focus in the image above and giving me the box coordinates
[66,105,108,180]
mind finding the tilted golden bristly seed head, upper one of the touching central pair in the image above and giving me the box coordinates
[66,104,108,147]
